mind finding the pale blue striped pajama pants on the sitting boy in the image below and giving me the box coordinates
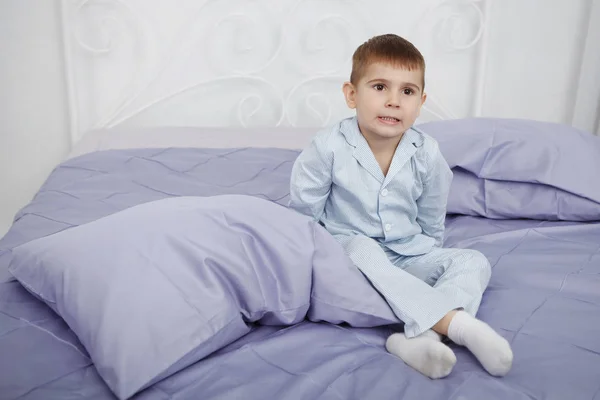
[335,235,492,337]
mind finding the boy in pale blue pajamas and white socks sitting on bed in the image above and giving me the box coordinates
[290,35,513,379]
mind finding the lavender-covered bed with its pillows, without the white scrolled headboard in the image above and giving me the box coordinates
[0,118,600,400]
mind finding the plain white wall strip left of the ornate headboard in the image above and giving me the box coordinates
[0,0,69,236]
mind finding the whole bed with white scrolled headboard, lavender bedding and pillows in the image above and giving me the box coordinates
[0,0,600,400]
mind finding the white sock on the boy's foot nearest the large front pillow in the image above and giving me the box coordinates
[385,330,456,379]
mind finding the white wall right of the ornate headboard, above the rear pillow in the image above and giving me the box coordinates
[484,0,600,125]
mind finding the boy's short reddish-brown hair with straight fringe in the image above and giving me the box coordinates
[350,34,425,89]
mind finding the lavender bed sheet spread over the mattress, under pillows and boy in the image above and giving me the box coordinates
[0,148,600,400]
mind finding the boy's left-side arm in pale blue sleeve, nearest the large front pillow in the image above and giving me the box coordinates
[289,137,333,221]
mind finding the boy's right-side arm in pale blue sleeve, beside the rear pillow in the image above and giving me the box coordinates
[417,144,452,247]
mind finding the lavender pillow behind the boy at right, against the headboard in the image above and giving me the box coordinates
[417,118,600,221]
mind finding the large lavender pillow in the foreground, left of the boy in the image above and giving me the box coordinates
[9,195,399,399]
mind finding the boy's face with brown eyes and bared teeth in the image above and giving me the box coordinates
[343,63,426,144]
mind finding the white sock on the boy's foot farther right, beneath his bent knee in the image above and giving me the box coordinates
[448,311,513,376]
